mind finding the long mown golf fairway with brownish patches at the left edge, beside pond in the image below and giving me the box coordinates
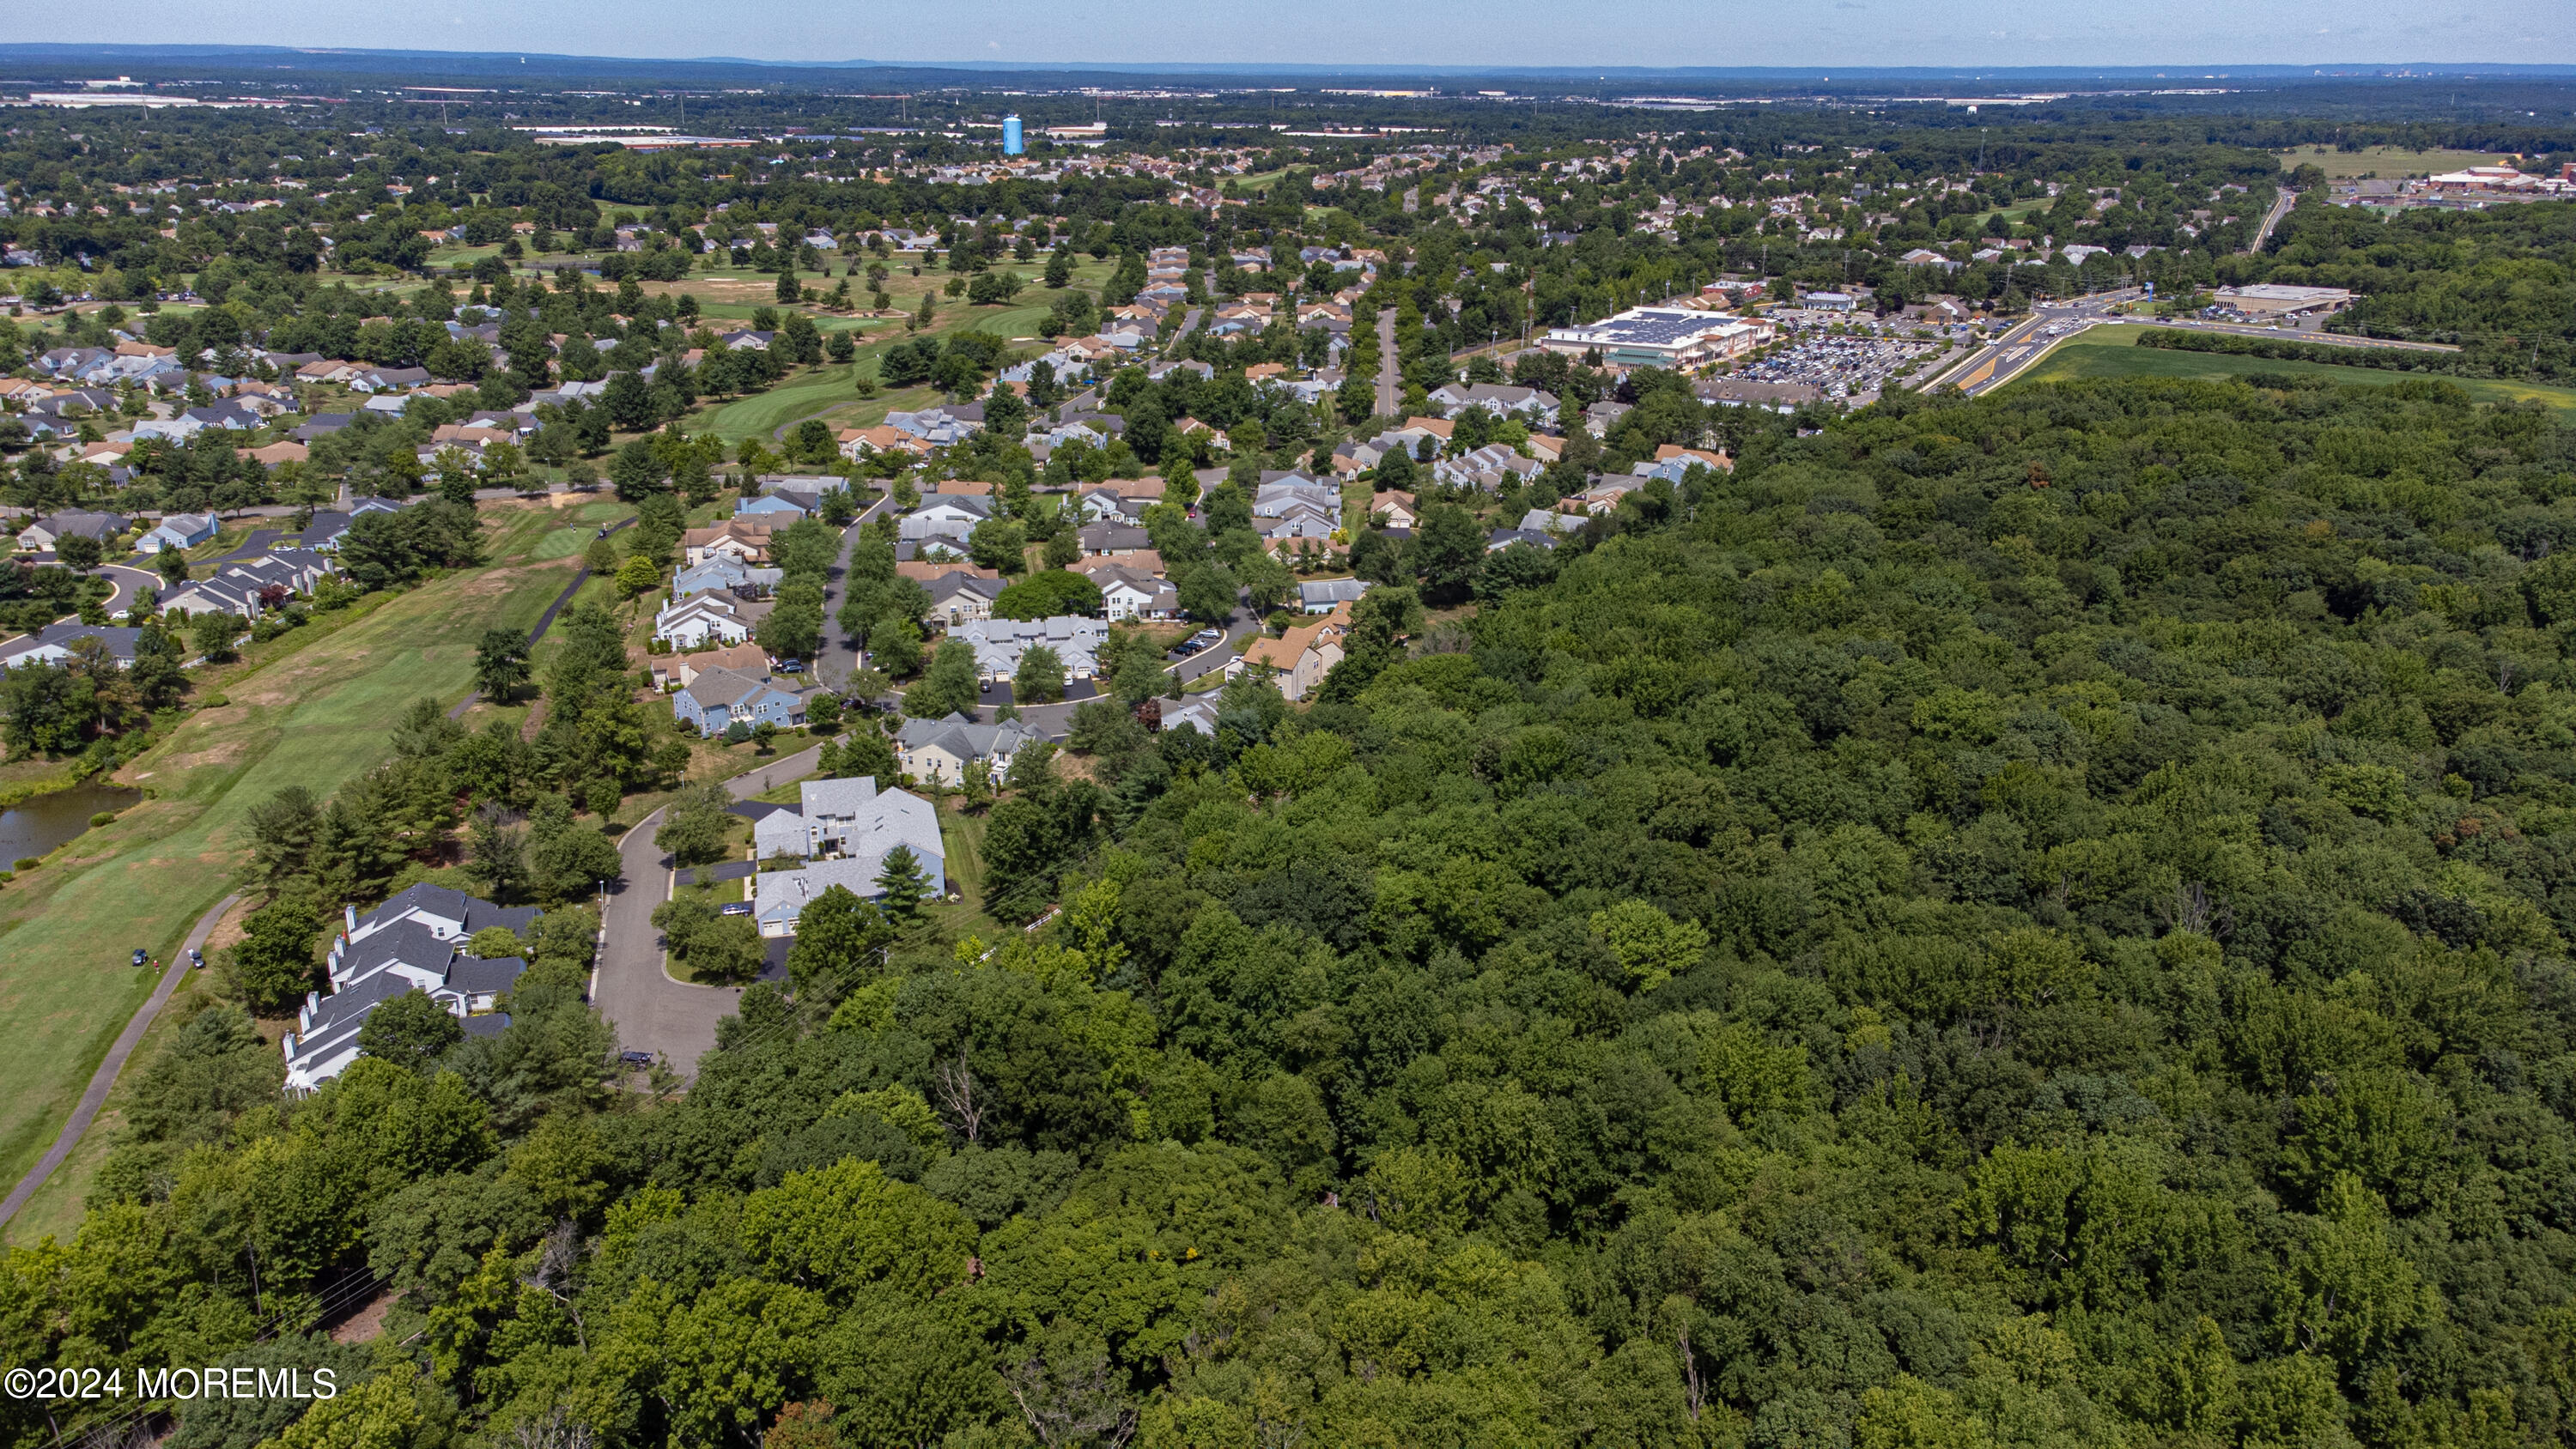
[0,545,585,1235]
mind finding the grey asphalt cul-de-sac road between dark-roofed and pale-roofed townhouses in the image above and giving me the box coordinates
[590,743,822,1078]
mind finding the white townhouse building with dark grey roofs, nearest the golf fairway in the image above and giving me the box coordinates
[281,885,536,1096]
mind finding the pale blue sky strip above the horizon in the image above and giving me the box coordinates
[39,0,2576,67]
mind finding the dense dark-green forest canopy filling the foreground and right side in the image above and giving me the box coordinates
[0,376,2576,1449]
